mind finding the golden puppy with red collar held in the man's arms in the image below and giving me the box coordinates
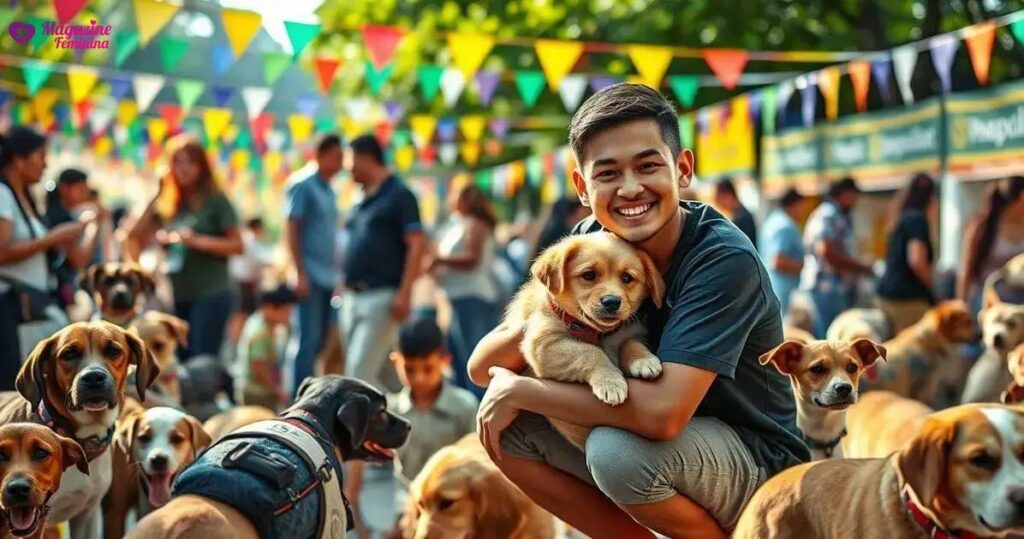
[505,233,665,447]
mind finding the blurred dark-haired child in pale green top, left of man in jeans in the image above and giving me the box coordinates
[236,285,298,410]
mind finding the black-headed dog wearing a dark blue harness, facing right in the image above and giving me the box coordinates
[128,375,410,539]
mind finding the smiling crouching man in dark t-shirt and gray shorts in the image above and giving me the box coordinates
[470,84,809,538]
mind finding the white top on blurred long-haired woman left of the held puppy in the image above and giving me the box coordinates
[437,214,498,301]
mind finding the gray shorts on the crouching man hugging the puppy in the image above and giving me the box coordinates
[502,412,766,530]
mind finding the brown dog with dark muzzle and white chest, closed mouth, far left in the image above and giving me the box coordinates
[0,322,160,539]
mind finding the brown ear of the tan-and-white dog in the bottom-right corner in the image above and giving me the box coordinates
[896,419,956,507]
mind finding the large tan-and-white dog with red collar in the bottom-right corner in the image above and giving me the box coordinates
[733,405,1024,539]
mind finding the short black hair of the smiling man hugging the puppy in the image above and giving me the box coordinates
[569,83,682,164]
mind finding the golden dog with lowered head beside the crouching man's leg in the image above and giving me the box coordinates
[401,434,555,539]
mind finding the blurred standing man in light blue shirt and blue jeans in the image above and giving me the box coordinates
[285,134,342,392]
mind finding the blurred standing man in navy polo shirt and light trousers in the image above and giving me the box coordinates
[342,135,426,391]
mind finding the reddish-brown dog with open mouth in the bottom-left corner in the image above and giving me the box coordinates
[0,423,89,539]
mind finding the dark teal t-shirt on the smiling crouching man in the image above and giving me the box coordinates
[574,202,810,476]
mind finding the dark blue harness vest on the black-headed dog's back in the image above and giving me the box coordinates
[172,412,353,539]
